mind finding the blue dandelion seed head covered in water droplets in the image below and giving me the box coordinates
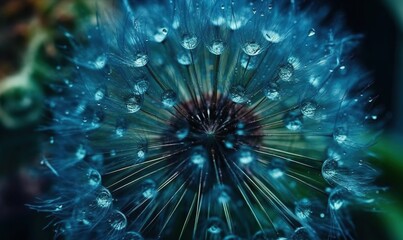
[31,0,379,240]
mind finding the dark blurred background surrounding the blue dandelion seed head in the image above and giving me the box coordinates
[0,0,403,240]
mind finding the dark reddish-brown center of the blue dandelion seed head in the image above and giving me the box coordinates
[162,96,261,180]
